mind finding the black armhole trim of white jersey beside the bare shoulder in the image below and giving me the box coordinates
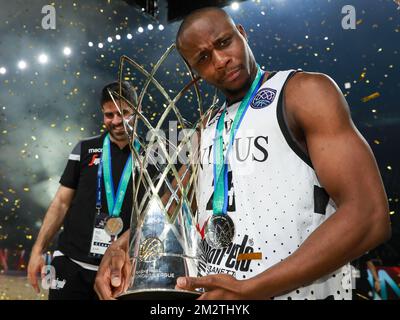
[276,71,314,169]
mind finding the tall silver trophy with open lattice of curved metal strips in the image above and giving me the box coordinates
[110,45,217,300]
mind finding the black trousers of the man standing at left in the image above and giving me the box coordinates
[49,256,98,300]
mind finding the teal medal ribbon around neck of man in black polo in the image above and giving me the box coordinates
[96,134,132,217]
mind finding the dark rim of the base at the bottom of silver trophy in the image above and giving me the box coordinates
[117,289,201,300]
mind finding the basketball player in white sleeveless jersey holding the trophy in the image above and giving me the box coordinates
[95,8,391,299]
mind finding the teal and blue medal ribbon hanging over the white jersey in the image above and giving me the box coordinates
[213,65,264,215]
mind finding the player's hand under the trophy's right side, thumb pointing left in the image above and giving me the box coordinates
[176,274,257,300]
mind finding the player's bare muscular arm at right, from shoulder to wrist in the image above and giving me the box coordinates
[242,73,391,297]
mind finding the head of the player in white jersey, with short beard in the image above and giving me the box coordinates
[176,7,257,100]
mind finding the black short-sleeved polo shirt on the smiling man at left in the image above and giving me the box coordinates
[58,133,137,265]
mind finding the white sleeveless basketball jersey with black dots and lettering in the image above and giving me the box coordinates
[197,70,352,299]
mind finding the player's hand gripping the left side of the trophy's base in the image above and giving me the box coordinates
[94,235,131,300]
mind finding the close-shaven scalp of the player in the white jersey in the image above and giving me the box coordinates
[176,7,235,50]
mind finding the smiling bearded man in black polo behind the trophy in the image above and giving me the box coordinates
[28,82,137,300]
